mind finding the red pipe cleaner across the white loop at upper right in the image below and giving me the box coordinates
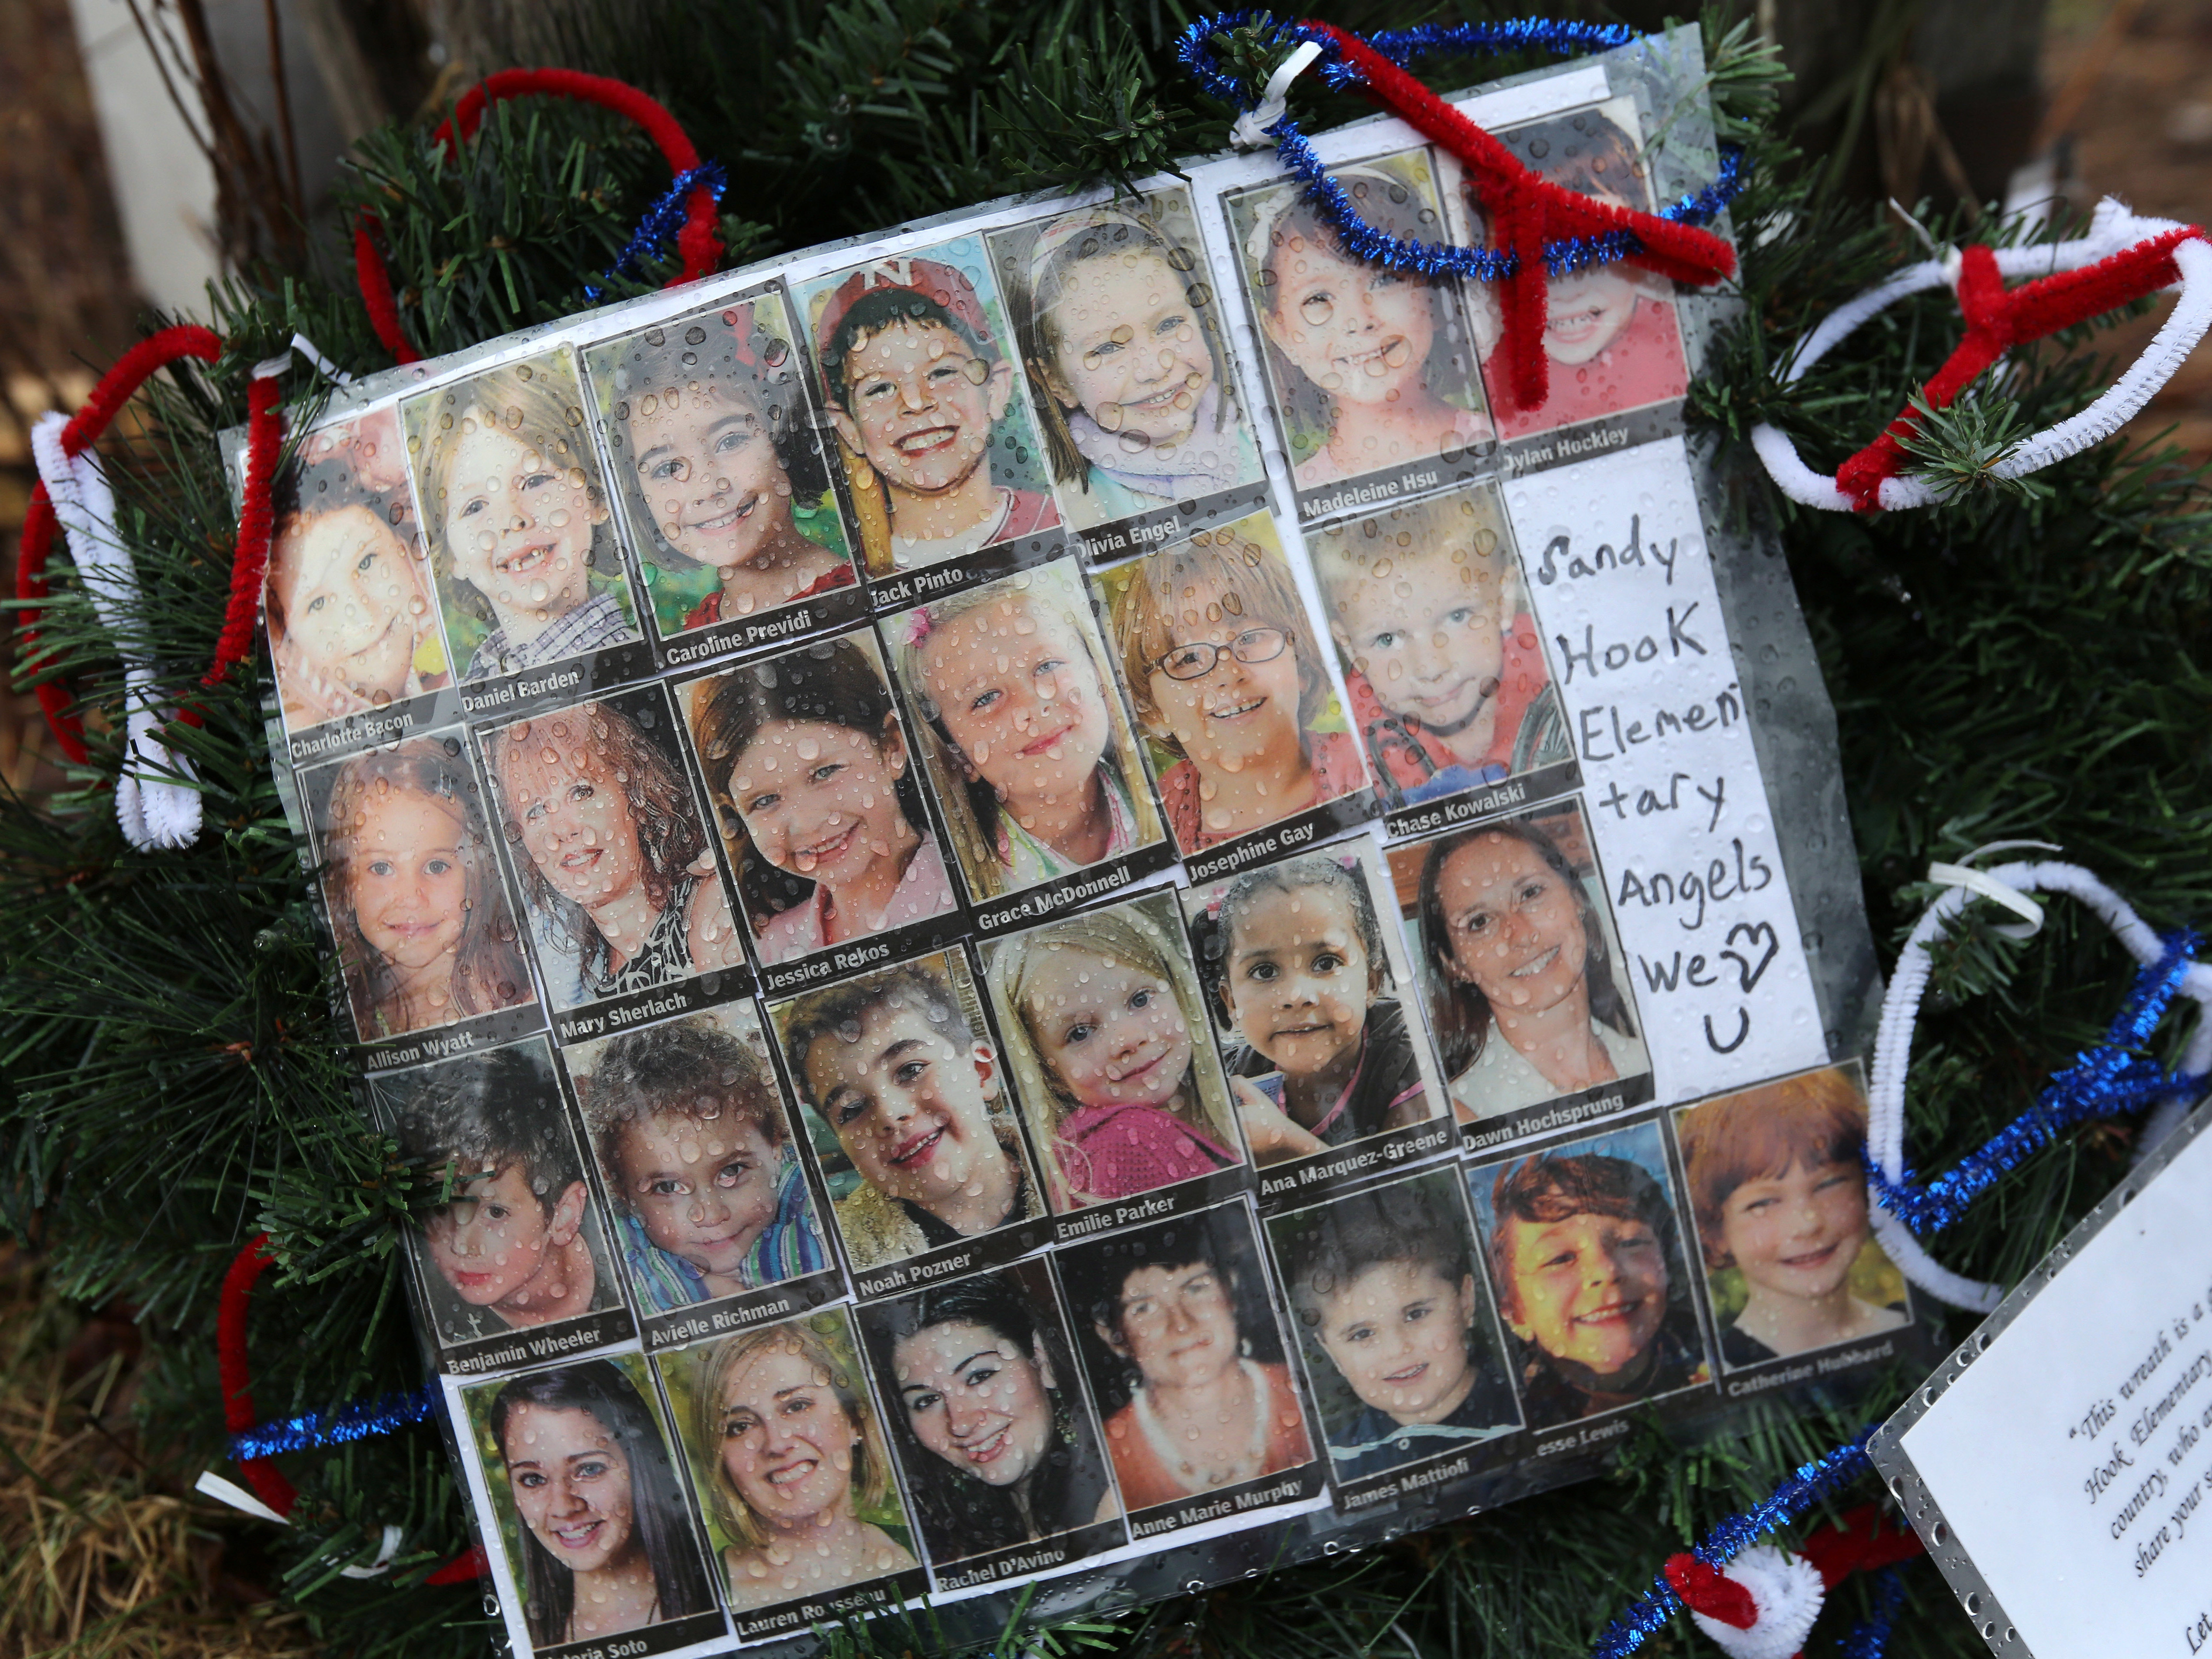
[1836,226,2203,513]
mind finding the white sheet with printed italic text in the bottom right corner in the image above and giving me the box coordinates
[1898,1110,2212,1659]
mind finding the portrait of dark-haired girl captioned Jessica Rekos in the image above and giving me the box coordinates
[677,628,960,967]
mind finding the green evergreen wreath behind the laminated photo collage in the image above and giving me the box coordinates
[0,13,2212,1659]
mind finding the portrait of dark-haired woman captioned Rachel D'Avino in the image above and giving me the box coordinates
[861,1263,1121,1566]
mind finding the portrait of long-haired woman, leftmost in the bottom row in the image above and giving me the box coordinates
[480,1361,714,1648]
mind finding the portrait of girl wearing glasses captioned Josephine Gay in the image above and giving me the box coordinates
[1097,516,1367,858]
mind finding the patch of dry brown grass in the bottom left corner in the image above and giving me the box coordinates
[0,1246,316,1659]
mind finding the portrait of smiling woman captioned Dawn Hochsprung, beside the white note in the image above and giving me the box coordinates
[1389,801,1650,1124]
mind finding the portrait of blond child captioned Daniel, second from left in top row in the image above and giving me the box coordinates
[400,347,639,683]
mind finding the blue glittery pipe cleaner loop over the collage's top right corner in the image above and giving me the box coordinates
[1175,11,1748,283]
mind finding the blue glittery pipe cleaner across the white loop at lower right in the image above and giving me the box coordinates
[1867,929,2206,1234]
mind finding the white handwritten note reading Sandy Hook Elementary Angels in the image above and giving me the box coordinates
[1506,440,1829,1102]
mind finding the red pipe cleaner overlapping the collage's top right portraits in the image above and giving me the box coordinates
[1299,20,1736,409]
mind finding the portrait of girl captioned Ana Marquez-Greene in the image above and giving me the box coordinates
[1184,841,1444,1168]
